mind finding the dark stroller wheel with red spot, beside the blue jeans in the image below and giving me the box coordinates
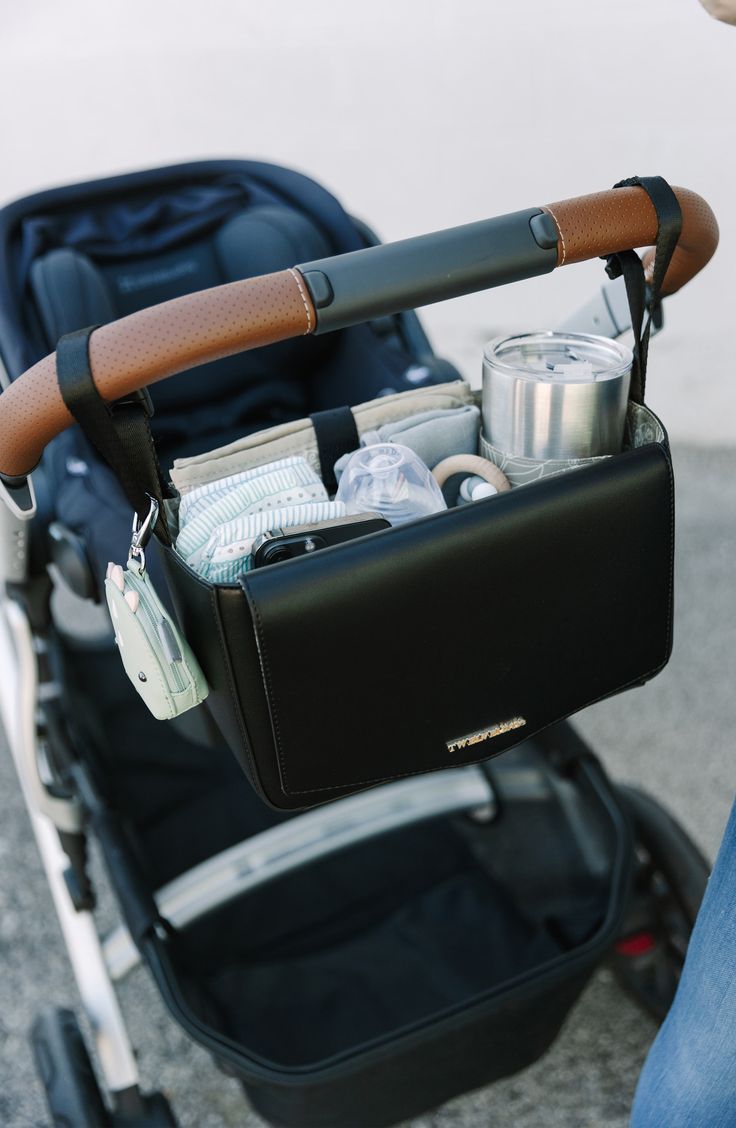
[611,786,710,1022]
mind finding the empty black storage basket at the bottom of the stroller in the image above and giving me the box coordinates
[133,725,631,1128]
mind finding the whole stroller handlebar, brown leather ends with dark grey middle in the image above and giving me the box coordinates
[0,187,718,485]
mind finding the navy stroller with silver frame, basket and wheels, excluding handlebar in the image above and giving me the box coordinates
[0,160,708,1128]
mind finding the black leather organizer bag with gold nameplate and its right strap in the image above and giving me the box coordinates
[58,178,680,810]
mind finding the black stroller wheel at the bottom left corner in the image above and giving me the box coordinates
[30,1006,111,1128]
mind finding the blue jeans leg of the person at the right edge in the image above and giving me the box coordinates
[631,803,736,1128]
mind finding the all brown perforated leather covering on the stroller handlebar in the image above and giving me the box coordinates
[0,181,718,477]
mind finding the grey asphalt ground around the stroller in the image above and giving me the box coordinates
[0,447,736,1128]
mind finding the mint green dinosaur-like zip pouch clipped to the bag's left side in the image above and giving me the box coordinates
[105,556,209,721]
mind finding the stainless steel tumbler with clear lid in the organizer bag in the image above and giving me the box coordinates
[483,332,632,461]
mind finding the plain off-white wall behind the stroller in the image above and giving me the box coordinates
[0,0,736,443]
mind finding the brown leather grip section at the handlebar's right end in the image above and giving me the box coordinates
[543,187,718,296]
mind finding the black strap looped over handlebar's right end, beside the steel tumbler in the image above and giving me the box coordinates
[606,176,682,404]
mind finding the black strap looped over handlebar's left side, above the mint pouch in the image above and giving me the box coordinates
[56,326,172,545]
